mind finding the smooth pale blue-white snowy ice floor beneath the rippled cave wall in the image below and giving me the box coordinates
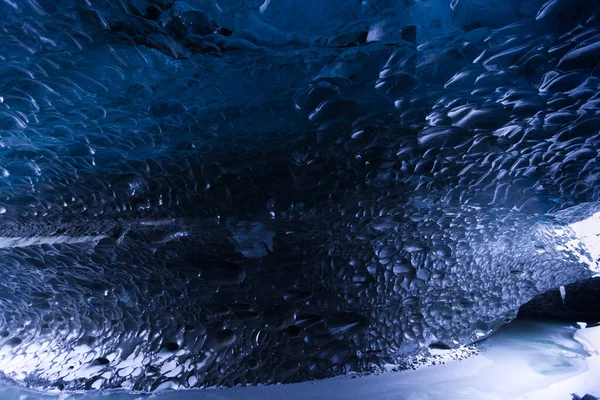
[0,320,600,400]
